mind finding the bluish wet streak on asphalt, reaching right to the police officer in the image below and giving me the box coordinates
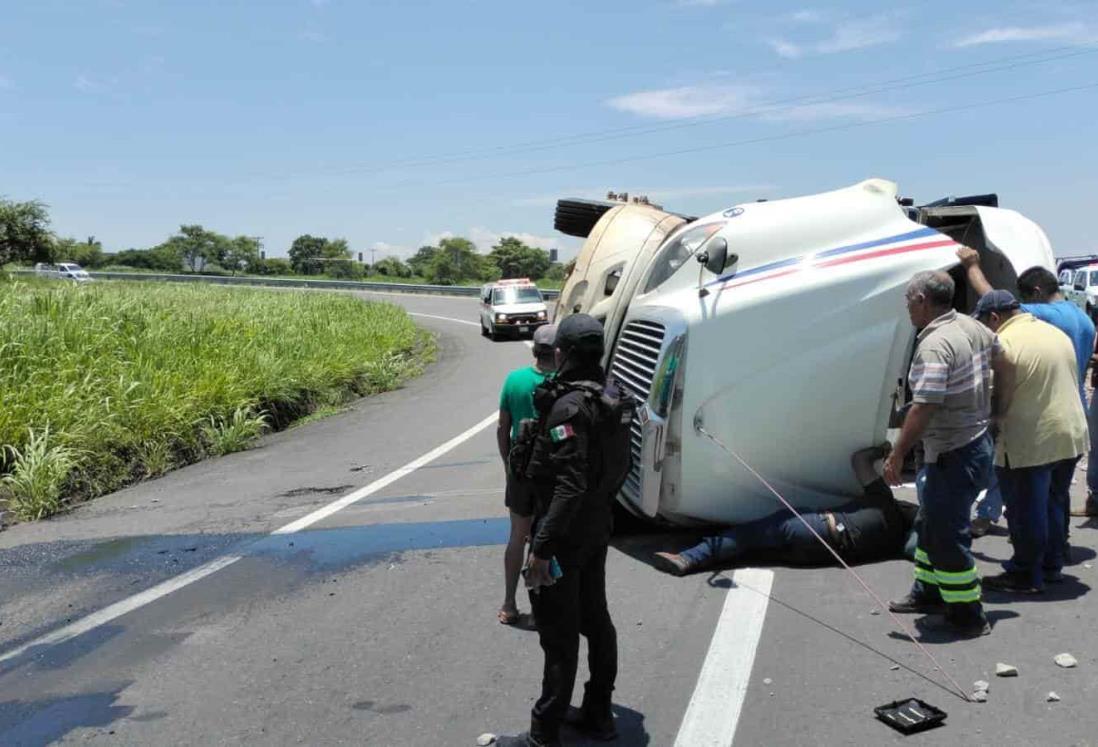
[249,519,511,568]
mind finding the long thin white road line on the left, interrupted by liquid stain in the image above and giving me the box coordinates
[0,412,500,662]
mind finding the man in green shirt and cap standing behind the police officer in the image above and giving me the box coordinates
[495,324,557,625]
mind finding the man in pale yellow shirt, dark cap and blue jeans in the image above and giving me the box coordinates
[973,290,1087,594]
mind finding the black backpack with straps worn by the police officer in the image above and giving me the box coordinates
[507,379,637,495]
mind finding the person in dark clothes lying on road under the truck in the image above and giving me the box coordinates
[656,444,915,576]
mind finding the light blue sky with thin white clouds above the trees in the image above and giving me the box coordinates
[0,0,1098,258]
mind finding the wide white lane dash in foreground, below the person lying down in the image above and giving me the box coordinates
[674,568,774,747]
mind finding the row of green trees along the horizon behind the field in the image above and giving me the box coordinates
[0,199,564,285]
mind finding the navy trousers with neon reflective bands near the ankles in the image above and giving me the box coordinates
[911,434,991,623]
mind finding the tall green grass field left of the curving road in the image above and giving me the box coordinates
[0,279,434,520]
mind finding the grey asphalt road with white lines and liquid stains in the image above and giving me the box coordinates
[0,287,1098,747]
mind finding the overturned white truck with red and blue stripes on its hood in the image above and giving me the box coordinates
[557,179,1054,525]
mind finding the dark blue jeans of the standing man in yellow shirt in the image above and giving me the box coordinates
[996,457,1078,589]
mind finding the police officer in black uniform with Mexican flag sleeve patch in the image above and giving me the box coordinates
[505,314,617,747]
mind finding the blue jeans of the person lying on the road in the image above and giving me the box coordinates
[679,513,831,566]
